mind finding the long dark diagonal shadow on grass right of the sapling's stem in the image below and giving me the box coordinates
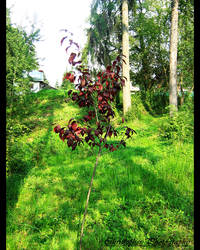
[100,146,193,217]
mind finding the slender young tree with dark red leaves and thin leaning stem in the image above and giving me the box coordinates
[54,30,136,249]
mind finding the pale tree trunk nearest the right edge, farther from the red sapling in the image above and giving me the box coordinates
[169,0,178,116]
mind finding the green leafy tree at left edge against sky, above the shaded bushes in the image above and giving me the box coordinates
[6,9,39,105]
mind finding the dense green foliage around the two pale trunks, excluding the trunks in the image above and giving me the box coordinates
[84,0,194,110]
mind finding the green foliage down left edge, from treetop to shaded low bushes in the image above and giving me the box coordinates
[6,9,39,173]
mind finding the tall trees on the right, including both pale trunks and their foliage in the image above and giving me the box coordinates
[83,0,194,115]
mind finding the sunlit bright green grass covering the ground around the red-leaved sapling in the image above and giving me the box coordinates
[6,90,194,250]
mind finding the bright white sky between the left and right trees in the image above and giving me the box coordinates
[6,0,92,86]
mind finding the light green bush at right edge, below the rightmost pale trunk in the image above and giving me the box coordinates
[159,101,194,142]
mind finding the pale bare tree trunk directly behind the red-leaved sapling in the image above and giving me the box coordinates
[122,0,131,115]
